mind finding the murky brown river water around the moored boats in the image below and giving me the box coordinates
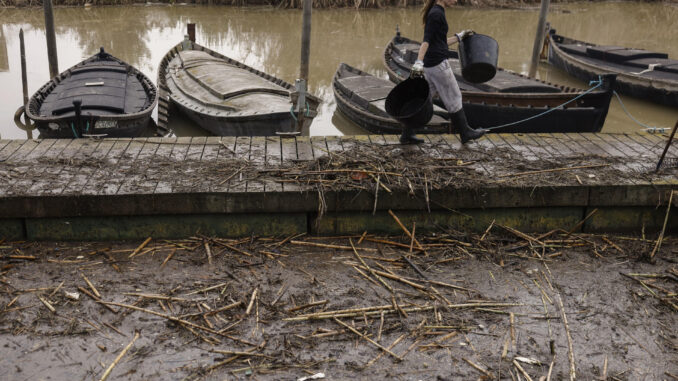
[0,3,678,138]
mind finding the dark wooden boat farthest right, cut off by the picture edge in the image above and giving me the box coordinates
[547,29,678,107]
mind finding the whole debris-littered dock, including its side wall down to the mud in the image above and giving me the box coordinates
[0,133,678,240]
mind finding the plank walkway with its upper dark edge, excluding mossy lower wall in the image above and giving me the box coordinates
[0,133,678,238]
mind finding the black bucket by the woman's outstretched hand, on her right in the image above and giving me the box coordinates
[459,34,499,83]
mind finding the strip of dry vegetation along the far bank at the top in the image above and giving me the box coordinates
[0,0,678,8]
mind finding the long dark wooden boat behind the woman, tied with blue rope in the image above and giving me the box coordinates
[384,32,615,133]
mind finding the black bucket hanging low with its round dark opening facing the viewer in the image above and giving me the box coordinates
[386,78,433,128]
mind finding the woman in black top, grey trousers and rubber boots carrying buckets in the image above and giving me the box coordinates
[410,0,487,144]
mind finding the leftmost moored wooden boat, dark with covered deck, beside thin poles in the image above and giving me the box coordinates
[25,48,158,138]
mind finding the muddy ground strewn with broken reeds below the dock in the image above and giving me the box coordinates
[0,226,678,380]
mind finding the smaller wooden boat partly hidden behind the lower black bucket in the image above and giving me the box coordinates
[332,63,450,134]
